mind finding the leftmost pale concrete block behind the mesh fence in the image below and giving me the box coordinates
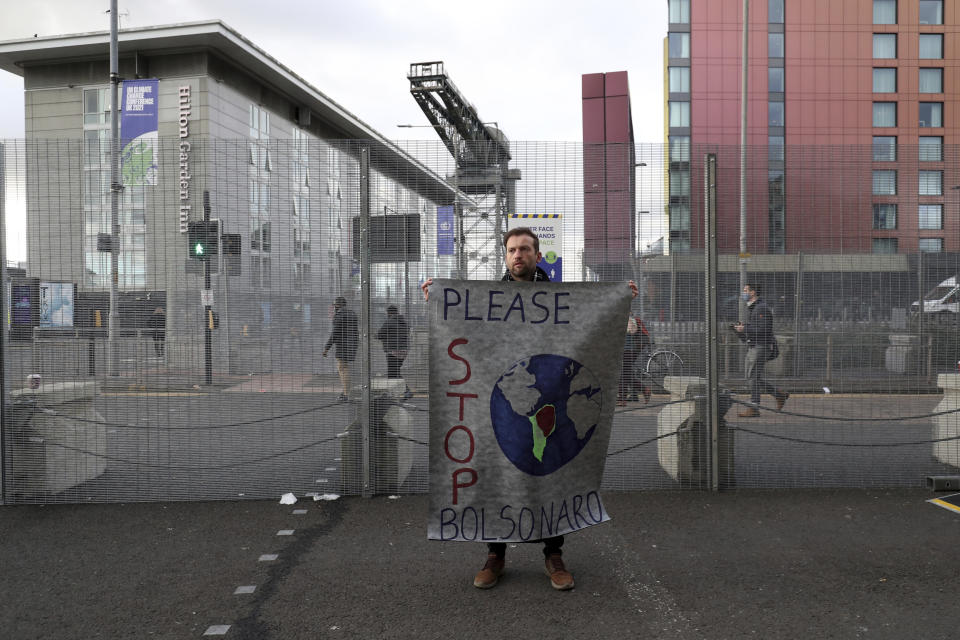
[8,382,107,497]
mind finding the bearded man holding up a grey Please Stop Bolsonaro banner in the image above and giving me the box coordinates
[422,227,637,590]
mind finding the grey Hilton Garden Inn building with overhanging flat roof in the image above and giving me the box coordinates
[0,21,455,370]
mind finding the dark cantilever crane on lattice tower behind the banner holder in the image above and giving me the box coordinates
[407,61,520,279]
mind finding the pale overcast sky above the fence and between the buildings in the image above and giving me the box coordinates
[0,0,667,254]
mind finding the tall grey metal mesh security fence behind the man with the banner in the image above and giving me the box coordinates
[0,141,960,503]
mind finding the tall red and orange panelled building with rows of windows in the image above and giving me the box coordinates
[667,0,960,254]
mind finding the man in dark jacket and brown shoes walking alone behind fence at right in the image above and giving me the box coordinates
[733,284,790,418]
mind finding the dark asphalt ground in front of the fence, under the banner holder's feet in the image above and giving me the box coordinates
[0,489,960,640]
